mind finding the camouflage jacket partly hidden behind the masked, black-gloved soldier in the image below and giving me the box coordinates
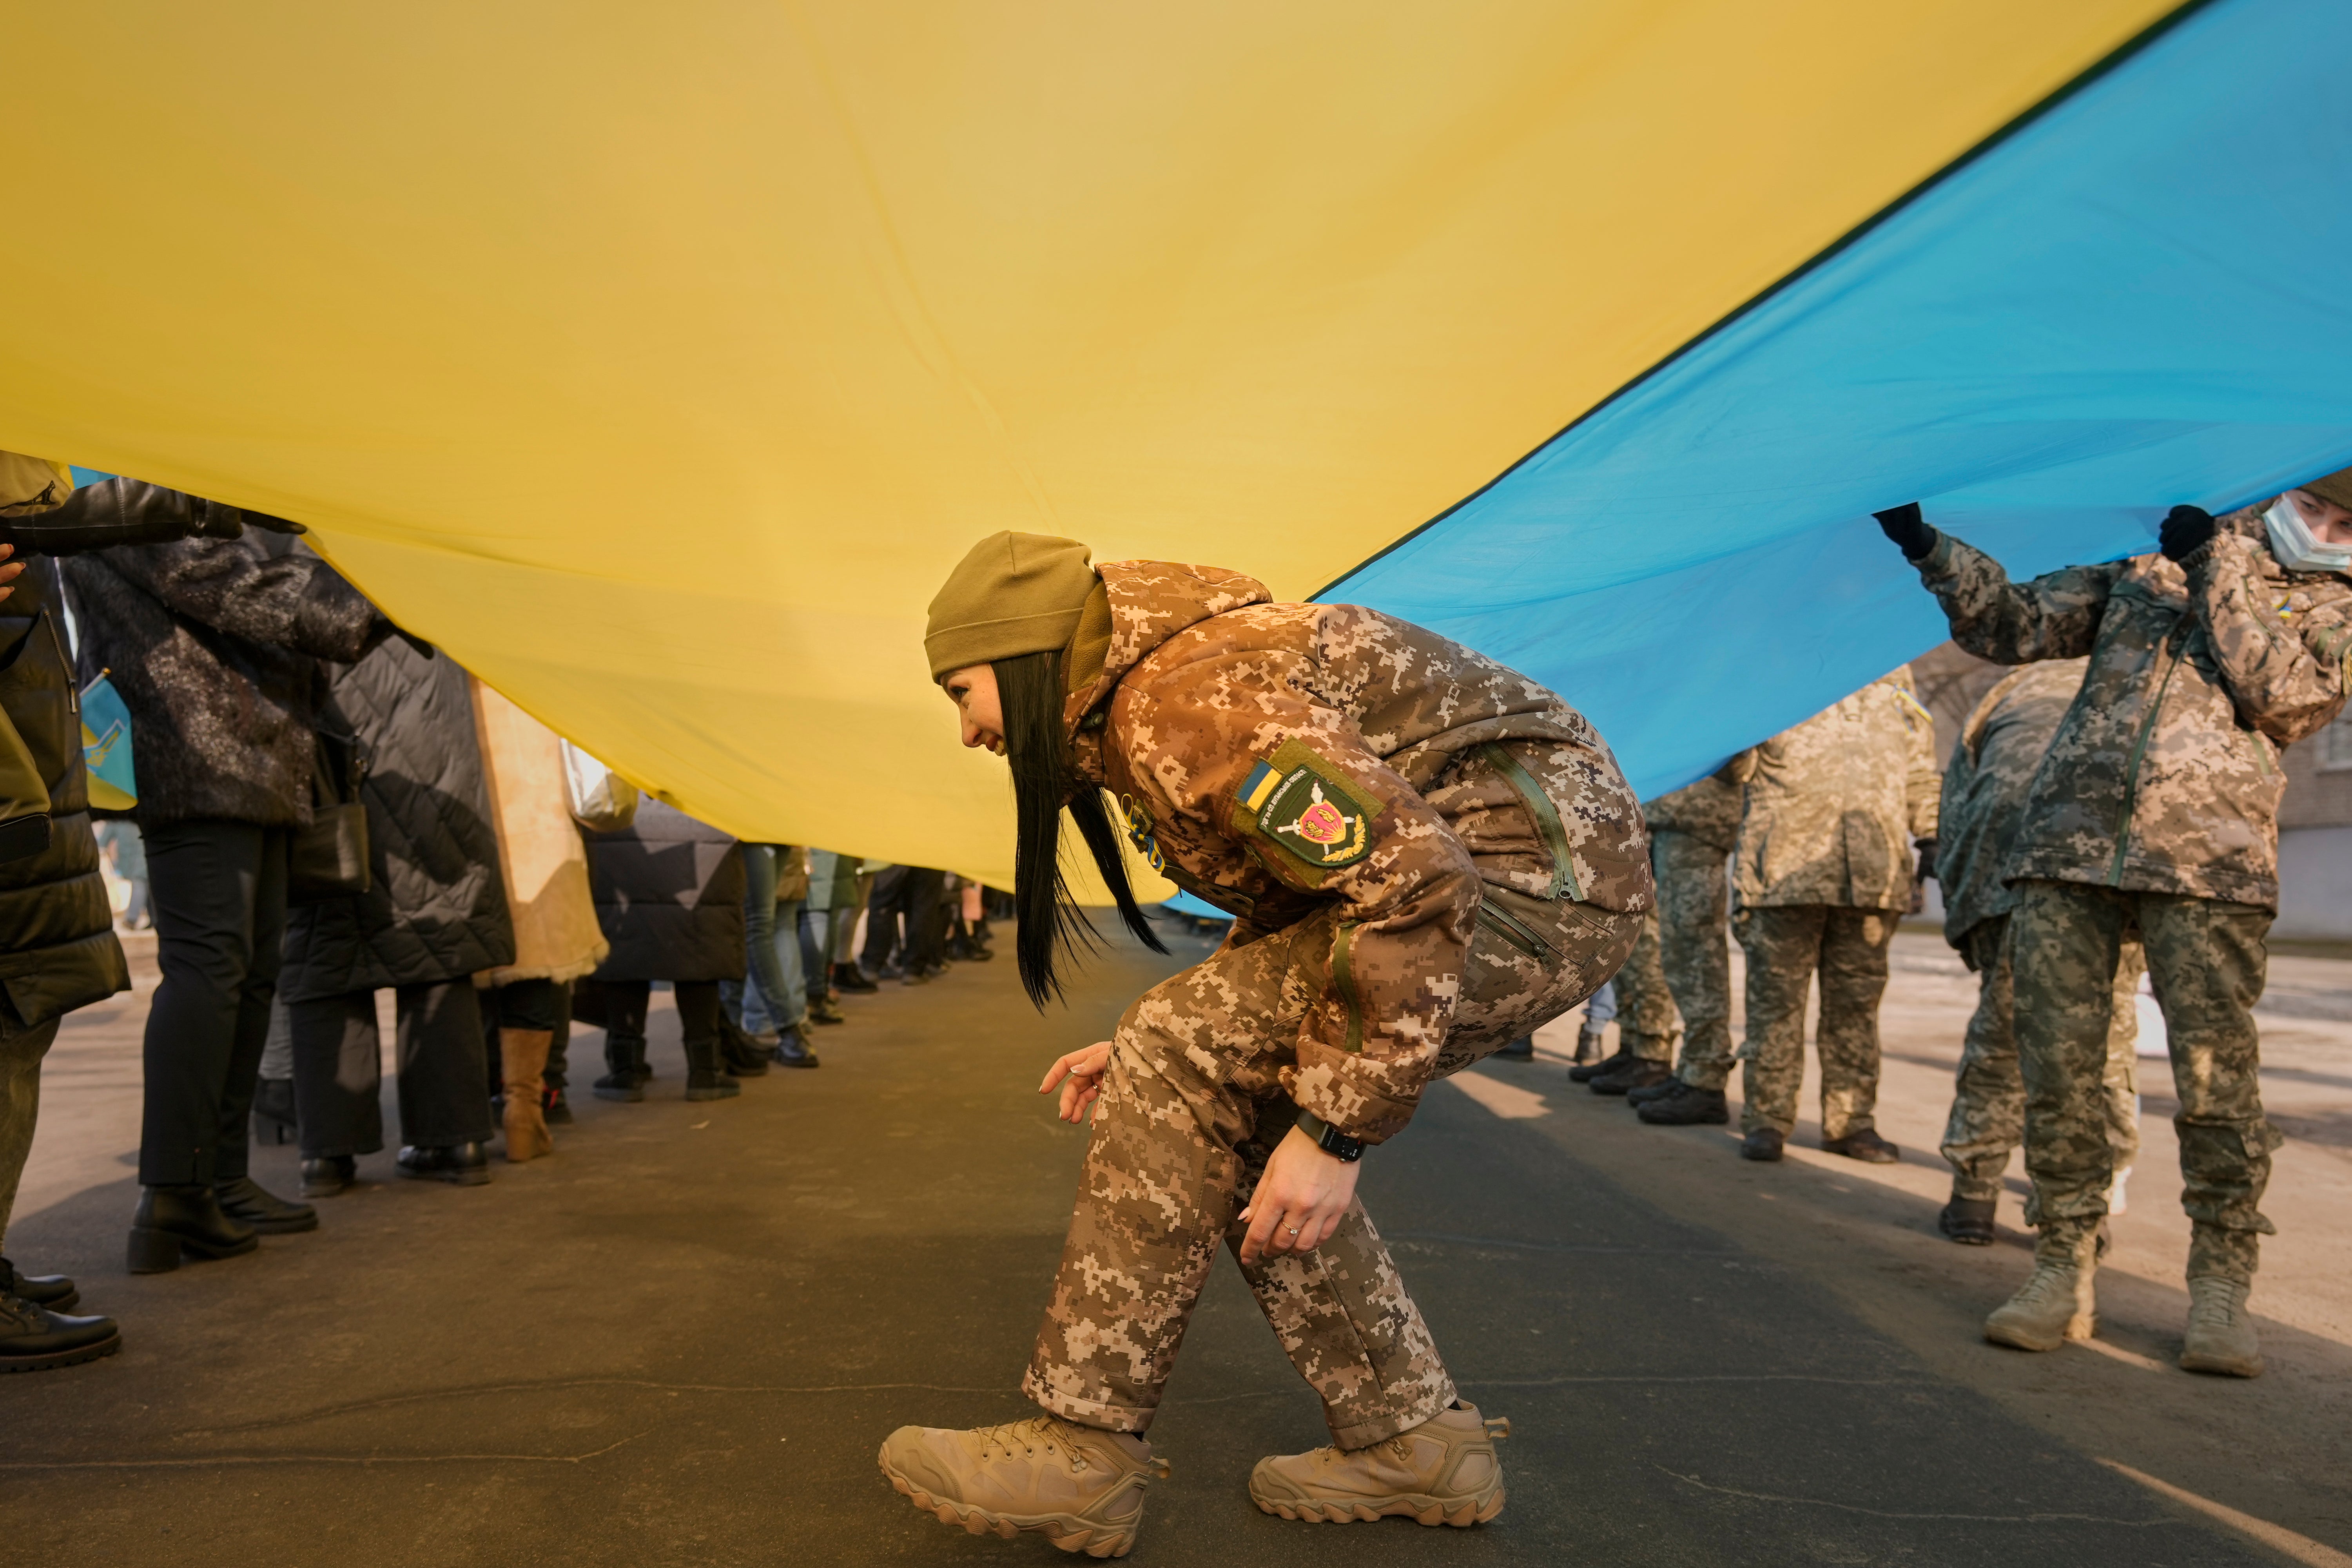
[1936,658,2091,957]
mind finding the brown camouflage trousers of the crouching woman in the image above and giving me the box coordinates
[1021,888,1639,1448]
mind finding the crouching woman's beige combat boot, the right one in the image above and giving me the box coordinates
[1249,1406,1510,1526]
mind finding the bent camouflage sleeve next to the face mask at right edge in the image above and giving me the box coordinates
[2183,534,2352,745]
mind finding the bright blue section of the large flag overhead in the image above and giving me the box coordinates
[1322,0,2352,797]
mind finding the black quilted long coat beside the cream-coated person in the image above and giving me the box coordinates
[277,637,515,1001]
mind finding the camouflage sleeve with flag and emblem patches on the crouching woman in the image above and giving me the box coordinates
[1115,665,1480,1142]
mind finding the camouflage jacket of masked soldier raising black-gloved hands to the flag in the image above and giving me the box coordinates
[1919,513,2352,910]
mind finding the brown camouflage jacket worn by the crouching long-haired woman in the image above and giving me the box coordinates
[1065,562,1651,1142]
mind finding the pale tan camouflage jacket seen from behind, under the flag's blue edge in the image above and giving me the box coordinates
[1726,668,1943,910]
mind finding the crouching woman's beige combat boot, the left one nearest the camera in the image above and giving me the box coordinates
[880,1415,1169,1556]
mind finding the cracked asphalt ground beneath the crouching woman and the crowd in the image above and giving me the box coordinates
[0,921,2352,1568]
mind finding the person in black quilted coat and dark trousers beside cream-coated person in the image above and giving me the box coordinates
[277,625,515,1196]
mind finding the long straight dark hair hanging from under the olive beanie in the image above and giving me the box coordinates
[992,651,1166,1011]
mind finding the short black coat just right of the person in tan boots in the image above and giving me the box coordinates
[586,799,745,980]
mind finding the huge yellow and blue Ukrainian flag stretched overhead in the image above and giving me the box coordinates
[0,0,2352,877]
